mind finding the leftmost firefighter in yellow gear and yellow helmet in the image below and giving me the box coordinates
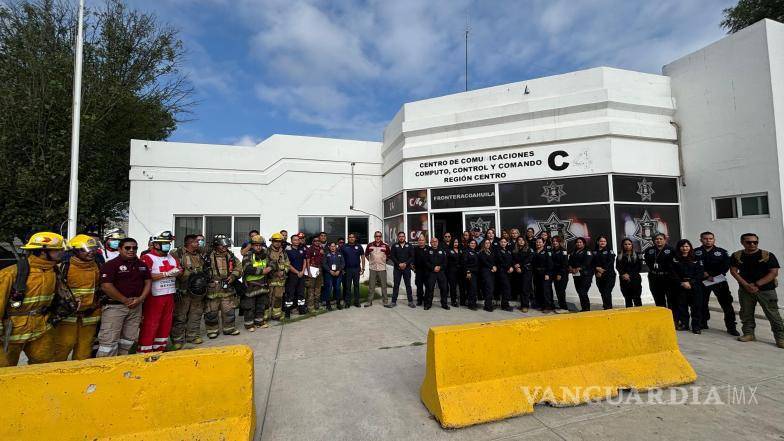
[0,232,65,367]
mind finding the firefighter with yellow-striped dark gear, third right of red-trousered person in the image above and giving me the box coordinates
[240,235,272,332]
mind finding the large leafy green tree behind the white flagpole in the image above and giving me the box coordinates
[0,0,193,238]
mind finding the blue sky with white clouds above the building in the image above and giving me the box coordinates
[125,0,735,145]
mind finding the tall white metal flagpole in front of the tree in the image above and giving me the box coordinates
[68,0,84,237]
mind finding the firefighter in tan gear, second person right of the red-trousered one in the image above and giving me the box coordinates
[204,234,242,339]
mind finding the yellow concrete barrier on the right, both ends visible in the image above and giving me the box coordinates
[420,306,697,428]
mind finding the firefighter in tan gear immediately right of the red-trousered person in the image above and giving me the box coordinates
[171,234,209,349]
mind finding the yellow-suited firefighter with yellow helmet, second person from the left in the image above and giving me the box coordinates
[54,234,101,361]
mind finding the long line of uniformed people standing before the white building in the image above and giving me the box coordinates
[0,225,784,367]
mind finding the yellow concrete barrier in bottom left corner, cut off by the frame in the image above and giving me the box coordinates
[0,346,255,441]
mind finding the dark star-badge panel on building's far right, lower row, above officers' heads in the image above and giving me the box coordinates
[615,204,681,253]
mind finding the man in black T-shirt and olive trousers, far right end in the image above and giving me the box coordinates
[730,233,784,349]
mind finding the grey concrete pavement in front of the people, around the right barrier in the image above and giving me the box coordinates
[201,302,784,441]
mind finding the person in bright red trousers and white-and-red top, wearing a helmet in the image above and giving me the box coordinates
[139,231,182,352]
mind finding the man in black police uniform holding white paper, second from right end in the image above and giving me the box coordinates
[694,231,740,337]
